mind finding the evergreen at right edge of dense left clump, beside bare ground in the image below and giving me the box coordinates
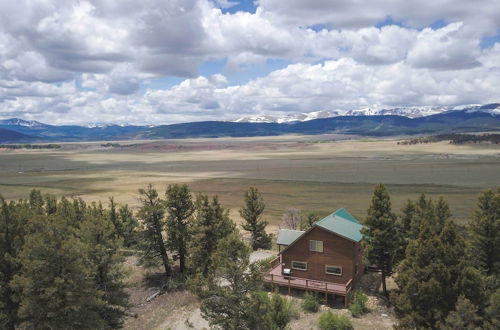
[78,204,128,329]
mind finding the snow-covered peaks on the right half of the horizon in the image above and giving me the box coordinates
[235,103,500,123]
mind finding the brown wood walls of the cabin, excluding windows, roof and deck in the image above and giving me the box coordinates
[281,226,364,285]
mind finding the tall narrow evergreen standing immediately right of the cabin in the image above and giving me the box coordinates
[361,184,401,296]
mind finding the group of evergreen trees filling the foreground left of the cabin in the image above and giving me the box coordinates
[0,185,272,329]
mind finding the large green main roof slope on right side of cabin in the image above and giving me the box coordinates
[314,209,363,242]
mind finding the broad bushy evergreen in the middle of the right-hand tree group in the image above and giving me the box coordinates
[391,203,481,329]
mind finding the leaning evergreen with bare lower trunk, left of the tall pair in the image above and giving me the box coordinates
[137,185,171,276]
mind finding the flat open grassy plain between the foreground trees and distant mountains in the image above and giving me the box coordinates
[0,135,500,230]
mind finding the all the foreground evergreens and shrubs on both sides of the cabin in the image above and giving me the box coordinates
[0,184,500,330]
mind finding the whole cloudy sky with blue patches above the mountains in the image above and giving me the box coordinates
[0,0,500,124]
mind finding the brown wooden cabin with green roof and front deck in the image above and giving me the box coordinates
[264,208,364,306]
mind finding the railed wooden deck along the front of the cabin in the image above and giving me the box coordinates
[264,260,352,297]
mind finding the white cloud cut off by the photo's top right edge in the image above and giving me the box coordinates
[258,0,500,32]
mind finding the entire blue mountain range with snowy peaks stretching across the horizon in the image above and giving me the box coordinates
[0,103,500,143]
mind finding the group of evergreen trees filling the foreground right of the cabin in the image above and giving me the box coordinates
[362,184,500,329]
